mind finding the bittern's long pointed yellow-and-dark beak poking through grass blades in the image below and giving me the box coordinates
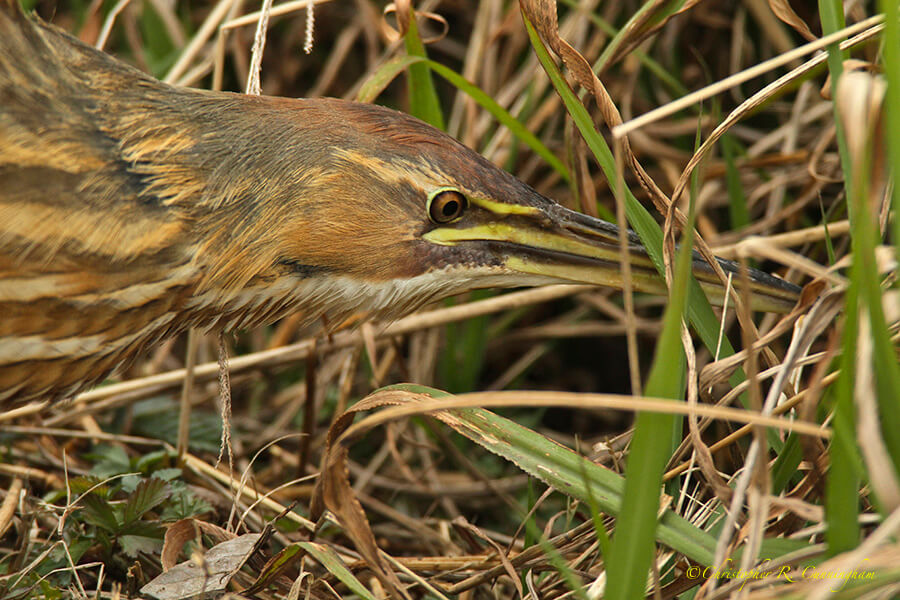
[424,198,800,313]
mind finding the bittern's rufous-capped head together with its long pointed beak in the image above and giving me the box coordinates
[192,99,796,324]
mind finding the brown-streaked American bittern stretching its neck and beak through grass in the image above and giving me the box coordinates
[0,0,798,404]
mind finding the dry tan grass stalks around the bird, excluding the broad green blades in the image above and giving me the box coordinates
[0,0,900,598]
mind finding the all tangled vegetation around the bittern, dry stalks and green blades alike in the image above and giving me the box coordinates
[0,0,900,599]
